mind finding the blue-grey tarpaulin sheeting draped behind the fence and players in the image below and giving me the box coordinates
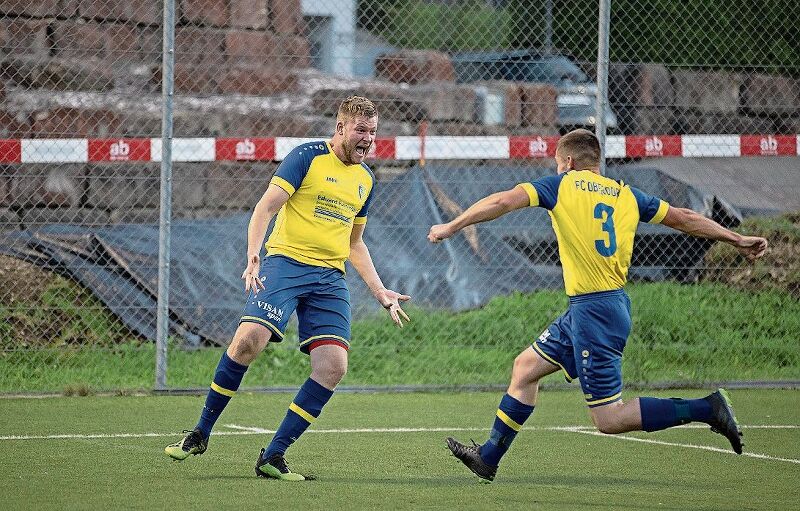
[0,166,739,344]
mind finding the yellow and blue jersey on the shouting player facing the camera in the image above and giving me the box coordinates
[265,141,375,272]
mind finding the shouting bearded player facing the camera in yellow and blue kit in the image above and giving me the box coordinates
[165,96,410,481]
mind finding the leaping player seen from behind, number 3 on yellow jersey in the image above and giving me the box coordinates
[428,130,767,481]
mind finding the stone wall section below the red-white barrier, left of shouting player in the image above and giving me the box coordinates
[0,162,277,232]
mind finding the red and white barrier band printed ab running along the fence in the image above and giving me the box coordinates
[0,135,800,163]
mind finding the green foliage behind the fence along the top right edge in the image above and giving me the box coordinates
[359,0,800,76]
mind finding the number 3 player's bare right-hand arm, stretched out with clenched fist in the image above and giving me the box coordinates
[661,206,767,261]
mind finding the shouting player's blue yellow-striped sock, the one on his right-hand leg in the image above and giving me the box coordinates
[264,378,333,458]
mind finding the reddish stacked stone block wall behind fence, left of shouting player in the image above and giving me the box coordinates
[0,0,310,230]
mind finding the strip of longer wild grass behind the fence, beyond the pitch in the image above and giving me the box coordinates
[0,282,800,393]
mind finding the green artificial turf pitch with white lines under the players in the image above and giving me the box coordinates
[0,389,800,511]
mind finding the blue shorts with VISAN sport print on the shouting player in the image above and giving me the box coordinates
[239,255,350,354]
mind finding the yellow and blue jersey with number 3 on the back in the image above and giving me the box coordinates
[518,170,669,296]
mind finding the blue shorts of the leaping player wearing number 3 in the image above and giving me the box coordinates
[533,289,631,407]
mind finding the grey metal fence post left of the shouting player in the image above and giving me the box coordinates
[155,0,175,390]
